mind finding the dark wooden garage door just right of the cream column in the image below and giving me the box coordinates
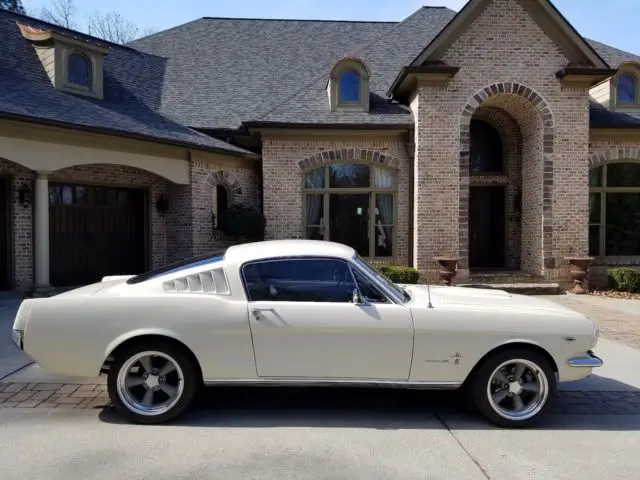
[49,183,146,287]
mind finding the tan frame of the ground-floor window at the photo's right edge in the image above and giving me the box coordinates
[587,163,640,265]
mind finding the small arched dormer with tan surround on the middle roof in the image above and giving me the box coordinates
[327,58,369,112]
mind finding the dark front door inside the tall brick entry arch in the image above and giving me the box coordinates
[469,186,506,268]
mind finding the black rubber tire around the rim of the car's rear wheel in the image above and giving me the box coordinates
[107,340,202,425]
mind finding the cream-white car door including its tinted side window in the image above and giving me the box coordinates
[242,257,414,380]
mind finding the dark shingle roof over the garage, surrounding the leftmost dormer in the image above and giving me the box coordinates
[0,10,255,155]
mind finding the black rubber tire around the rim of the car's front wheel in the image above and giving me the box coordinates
[470,348,558,428]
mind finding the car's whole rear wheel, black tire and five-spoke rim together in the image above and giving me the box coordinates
[107,341,199,424]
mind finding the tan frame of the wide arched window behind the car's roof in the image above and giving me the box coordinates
[301,160,399,262]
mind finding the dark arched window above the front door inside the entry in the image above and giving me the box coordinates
[469,120,504,174]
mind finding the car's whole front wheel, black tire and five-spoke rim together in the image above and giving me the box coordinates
[472,349,558,428]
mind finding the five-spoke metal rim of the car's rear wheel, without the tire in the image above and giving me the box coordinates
[118,351,184,415]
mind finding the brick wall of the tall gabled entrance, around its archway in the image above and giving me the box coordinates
[412,0,588,277]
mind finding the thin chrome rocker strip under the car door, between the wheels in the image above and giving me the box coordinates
[204,378,462,390]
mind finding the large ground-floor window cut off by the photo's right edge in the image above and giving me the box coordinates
[589,162,640,258]
